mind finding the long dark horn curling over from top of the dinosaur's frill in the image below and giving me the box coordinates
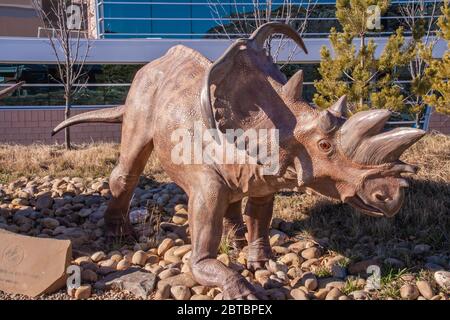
[249,22,308,53]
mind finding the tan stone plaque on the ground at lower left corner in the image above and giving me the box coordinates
[0,232,72,297]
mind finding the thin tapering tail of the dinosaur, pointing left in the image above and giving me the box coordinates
[52,105,125,136]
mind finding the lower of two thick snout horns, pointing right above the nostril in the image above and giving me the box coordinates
[352,128,425,165]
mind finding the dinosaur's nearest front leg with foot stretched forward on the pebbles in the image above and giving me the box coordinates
[189,179,255,299]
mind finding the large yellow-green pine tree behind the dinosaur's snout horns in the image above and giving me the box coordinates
[314,0,411,111]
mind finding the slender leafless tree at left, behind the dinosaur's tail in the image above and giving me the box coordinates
[33,0,91,149]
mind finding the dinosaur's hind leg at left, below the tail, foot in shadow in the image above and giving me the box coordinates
[105,122,153,242]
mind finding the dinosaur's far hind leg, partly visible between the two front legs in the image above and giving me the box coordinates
[222,200,247,249]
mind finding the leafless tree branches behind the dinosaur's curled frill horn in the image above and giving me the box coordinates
[208,0,317,68]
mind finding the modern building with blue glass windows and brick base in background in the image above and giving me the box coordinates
[0,0,450,143]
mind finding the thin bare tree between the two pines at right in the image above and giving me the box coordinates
[399,0,442,127]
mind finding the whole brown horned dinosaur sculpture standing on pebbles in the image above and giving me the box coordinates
[53,23,425,299]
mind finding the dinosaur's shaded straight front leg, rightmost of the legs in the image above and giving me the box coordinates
[245,195,274,270]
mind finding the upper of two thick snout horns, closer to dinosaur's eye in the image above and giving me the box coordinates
[340,110,391,158]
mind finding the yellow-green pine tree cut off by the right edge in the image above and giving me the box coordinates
[422,0,450,114]
